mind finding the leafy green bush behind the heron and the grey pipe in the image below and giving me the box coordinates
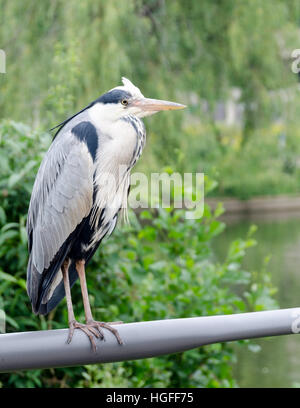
[0,121,275,387]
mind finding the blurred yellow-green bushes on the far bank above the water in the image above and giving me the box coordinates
[176,121,300,199]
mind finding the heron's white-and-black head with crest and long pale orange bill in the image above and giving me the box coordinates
[94,77,185,120]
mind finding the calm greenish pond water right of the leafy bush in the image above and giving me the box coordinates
[215,213,300,387]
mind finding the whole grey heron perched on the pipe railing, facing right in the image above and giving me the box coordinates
[26,78,185,350]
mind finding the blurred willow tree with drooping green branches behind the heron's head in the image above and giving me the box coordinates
[0,0,300,162]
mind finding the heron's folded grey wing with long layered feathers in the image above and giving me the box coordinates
[27,130,93,306]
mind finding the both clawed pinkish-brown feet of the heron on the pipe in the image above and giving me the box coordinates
[67,320,123,352]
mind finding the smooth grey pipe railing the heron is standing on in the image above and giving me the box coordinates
[0,308,300,372]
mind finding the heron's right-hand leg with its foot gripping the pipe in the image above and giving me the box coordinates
[76,260,123,344]
